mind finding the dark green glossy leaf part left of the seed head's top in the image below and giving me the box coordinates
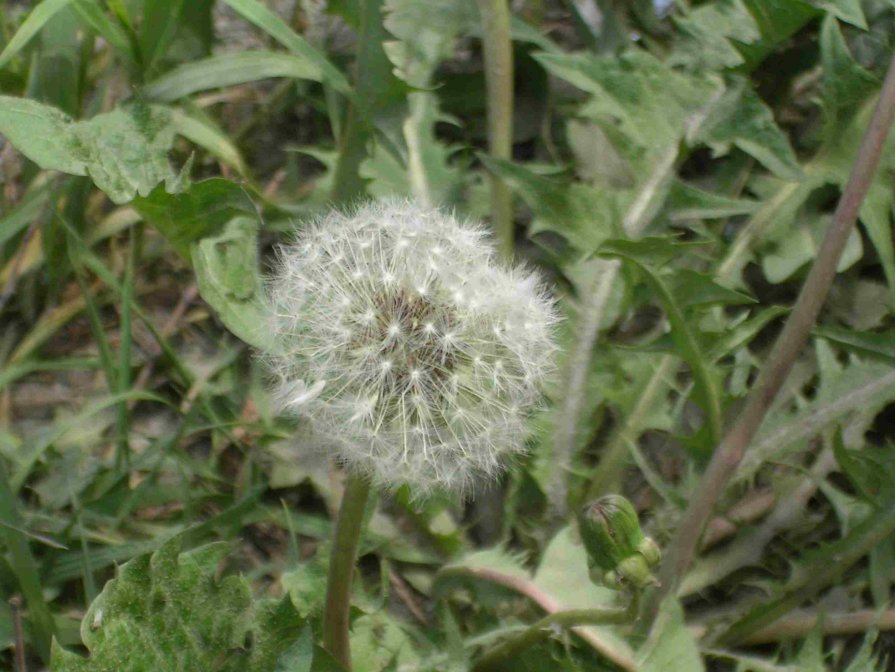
[134,177,257,258]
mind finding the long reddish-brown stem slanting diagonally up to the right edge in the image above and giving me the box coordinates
[649,52,895,615]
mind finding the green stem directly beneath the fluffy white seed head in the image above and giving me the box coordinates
[323,474,370,672]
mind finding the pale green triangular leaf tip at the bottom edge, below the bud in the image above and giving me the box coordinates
[637,595,705,672]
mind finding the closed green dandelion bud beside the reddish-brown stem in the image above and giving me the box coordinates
[578,495,661,588]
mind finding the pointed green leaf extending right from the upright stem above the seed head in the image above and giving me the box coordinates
[479,154,619,252]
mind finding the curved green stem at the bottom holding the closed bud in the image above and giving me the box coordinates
[472,592,640,672]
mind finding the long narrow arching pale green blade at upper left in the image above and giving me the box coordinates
[143,51,323,102]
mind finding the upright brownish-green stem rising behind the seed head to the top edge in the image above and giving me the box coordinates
[479,0,513,260]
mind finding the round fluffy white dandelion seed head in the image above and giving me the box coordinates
[268,201,557,494]
